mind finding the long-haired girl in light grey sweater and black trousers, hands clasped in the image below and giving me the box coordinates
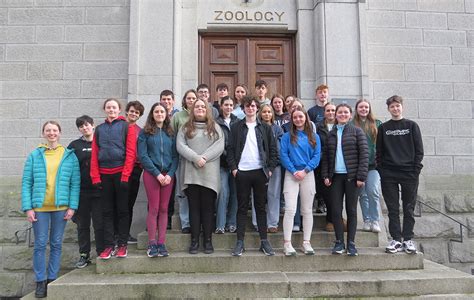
[176,100,225,254]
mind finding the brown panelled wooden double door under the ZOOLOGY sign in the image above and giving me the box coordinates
[199,35,296,98]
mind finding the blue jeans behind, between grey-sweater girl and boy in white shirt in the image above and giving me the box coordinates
[216,168,237,229]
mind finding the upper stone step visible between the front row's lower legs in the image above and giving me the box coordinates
[137,230,379,251]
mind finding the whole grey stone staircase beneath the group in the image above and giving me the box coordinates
[24,215,474,299]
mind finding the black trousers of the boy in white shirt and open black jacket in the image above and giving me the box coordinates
[235,169,268,240]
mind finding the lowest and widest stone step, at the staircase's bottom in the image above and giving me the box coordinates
[24,256,474,299]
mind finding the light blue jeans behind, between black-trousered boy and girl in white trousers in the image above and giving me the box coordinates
[252,166,281,227]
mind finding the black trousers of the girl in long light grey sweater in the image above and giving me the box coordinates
[185,184,217,242]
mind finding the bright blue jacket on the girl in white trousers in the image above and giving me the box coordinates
[280,130,321,174]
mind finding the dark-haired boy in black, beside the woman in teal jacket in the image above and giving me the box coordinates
[68,115,104,269]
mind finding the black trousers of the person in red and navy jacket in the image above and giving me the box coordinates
[101,173,129,247]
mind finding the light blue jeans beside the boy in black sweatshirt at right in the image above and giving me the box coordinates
[359,170,380,222]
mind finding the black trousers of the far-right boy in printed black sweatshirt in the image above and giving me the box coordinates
[381,176,419,242]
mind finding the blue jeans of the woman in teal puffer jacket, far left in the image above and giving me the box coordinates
[33,210,67,281]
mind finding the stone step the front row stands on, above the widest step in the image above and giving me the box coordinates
[97,248,423,273]
